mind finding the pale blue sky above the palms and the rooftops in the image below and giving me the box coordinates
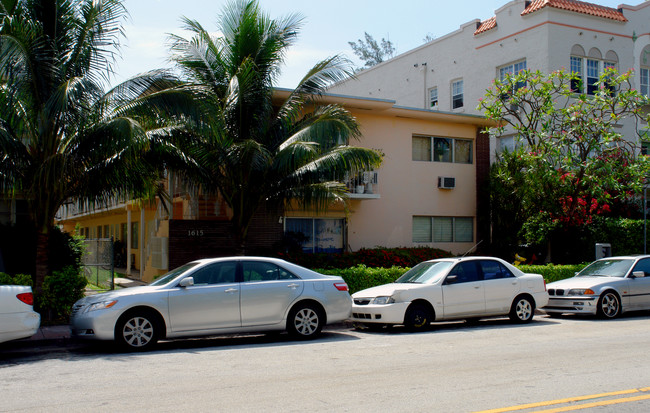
[112,0,642,88]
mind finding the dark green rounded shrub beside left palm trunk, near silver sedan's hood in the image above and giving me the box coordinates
[38,266,87,322]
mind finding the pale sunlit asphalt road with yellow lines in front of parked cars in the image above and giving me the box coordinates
[0,313,650,412]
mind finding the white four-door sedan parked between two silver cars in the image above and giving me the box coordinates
[352,257,548,330]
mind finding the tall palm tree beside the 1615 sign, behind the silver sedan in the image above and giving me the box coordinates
[170,0,381,254]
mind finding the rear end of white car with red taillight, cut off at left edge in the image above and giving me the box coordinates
[0,285,41,343]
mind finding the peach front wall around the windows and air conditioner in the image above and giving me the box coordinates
[348,109,477,253]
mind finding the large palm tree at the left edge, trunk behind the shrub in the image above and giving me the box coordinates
[0,0,194,294]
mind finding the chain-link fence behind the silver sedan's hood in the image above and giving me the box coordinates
[82,238,115,290]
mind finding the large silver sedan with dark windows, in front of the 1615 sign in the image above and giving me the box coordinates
[71,257,352,350]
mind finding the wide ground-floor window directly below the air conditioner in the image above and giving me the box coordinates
[413,216,474,242]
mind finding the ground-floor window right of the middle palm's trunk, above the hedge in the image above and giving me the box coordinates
[284,218,344,252]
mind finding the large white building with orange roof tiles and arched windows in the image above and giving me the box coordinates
[330,0,650,150]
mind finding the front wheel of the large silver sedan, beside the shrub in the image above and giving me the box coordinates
[115,310,160,351]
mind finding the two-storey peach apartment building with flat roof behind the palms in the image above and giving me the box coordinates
[58,90,492,281]
